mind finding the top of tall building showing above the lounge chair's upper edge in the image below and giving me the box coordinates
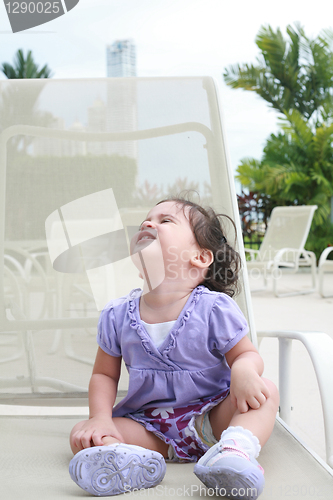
[106,39,136,78]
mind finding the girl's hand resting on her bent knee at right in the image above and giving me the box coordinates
[230,359,270,413]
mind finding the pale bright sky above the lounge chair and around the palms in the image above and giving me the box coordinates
[0,0,333,184]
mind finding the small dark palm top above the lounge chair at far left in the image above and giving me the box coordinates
[1,49,51,79]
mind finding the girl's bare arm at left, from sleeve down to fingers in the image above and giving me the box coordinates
[73,347,124,449]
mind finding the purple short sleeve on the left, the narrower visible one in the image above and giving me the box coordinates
[97,306,121,357]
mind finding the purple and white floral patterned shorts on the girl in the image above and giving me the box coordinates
[124,389,229,462]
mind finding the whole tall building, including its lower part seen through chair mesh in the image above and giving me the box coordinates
[106,40,137,159]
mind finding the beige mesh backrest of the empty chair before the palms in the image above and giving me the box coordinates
[259,205,317,261]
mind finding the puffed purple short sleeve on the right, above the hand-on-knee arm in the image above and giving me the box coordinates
[208,293,249,354]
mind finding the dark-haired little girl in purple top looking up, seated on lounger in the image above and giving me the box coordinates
[70,198,279,500]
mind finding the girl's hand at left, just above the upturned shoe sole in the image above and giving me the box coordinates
[73,415,124,450]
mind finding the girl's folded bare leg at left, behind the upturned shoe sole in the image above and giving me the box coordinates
[70,417,169,458]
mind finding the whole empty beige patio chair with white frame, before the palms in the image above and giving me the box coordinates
[245,205,317,297]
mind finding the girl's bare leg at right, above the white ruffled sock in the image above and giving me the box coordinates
[209,379,279,446]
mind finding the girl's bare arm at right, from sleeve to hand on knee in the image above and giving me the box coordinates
[225,337,270,413]
